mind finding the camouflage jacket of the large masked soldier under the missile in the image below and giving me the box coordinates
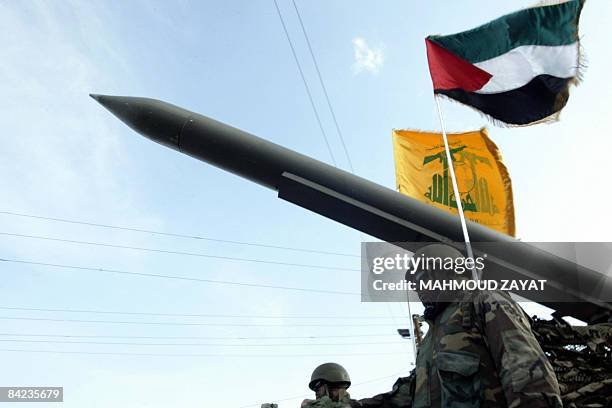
[413,292,562,408]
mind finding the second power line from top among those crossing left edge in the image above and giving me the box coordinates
[0,232,359,272]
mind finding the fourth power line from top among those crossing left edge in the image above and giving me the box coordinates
[0,306,389,320]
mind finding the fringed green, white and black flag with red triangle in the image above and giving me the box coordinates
[425,0,584,125]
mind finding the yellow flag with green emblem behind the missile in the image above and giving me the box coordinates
[393,128,515,236]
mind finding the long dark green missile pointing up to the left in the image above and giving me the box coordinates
[90,94,612,322]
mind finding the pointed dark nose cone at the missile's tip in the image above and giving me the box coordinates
[89,94,192,150]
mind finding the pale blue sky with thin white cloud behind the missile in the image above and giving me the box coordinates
[0,0,612,407]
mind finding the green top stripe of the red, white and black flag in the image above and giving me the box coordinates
[429,0,583,64]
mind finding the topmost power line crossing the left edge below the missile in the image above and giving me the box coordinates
[0,211,359,258]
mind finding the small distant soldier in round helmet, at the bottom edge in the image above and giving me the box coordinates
[302,363,359,408]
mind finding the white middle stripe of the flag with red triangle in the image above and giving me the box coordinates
[474,42,578,94]
